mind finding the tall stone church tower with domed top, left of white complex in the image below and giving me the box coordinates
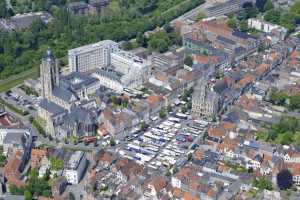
[40,49,59,100]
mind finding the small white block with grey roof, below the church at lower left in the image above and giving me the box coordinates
[65,151,87,184]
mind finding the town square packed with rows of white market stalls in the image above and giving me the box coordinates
[119,113,209,169]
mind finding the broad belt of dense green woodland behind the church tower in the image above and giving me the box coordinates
[0,0,203,79]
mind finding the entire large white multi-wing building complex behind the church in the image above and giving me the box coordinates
[69,40,151,93]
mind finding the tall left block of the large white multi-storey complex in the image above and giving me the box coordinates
[68,40,119,72]
